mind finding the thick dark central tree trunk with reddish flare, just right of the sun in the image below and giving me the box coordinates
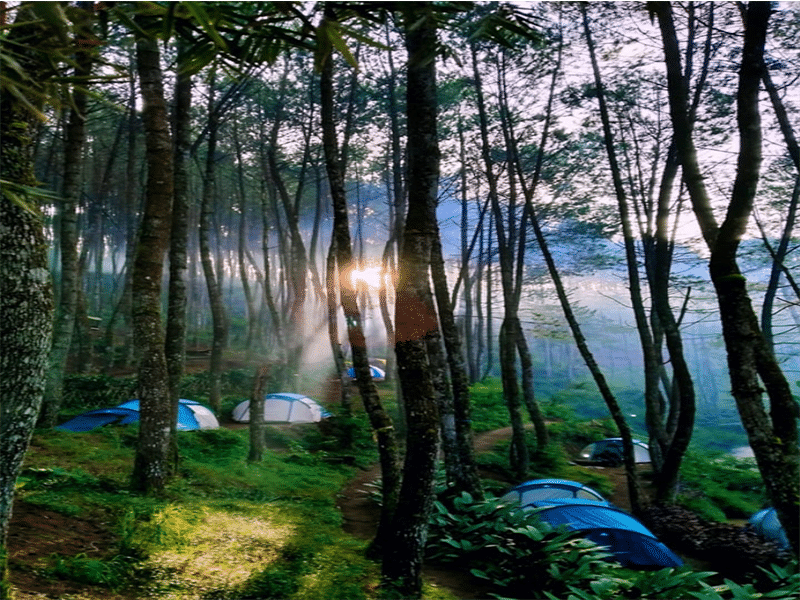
[382,2,440,599]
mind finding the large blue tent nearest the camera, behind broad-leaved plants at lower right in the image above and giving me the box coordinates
[527,498,683,569]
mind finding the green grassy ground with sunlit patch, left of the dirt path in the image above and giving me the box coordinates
[17,428,452,600]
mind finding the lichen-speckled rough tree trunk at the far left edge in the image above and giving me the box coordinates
[0,8,53,600]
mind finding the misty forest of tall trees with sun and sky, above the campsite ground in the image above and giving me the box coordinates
[0,1,800,598]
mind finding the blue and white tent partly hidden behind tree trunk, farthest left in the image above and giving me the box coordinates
[56,398,219,432]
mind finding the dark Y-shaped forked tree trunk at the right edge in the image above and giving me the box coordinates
[651,2,800,554]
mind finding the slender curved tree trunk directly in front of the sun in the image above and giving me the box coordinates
[320,21,400,553]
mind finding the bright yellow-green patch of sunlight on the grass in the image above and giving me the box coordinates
[142,510,295,600]
